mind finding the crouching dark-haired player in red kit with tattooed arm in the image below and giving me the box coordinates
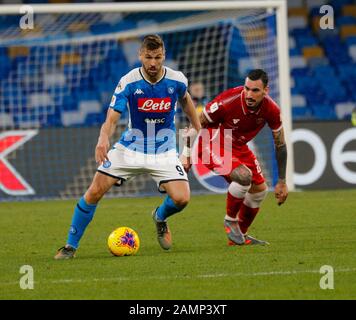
[193,69,288,245]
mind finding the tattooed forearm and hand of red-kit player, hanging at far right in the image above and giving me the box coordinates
[272,127,288,205]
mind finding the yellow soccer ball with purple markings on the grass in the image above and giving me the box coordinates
[108,227,140,257]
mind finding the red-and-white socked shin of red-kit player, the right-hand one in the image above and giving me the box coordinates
[238,189,268,234]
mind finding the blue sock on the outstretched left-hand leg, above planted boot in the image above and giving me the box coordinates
[67,197,96,249]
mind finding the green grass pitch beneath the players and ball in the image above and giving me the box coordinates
[0,190,356,300]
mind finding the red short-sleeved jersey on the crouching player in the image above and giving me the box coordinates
[203,86,282,150]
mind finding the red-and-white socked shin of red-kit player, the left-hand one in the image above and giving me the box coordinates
[225,182,250,221]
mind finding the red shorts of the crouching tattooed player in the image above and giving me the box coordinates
[197,145,265,185]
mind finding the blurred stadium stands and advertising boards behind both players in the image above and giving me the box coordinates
[0,0,356,200]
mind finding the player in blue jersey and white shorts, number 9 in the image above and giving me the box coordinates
[54,35,200,259]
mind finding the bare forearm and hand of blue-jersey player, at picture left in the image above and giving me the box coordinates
[95,108,121,164]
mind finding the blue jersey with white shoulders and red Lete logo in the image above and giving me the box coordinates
[110,67,188,153]
